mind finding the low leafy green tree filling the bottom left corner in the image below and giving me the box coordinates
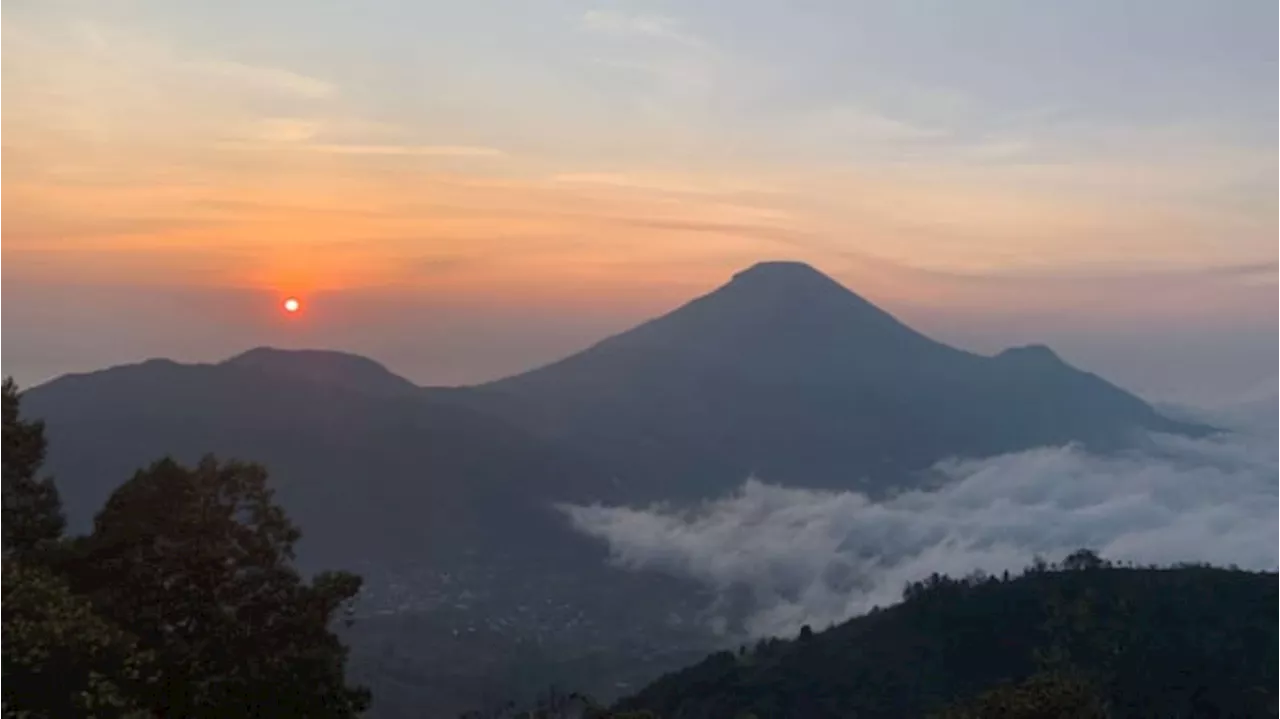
[0,559,154,719]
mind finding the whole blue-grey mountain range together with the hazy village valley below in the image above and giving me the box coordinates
[23,264,1207,716]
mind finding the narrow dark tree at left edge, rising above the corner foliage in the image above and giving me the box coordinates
[0,379,65,558]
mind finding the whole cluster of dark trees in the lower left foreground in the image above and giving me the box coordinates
[0,380,370,719]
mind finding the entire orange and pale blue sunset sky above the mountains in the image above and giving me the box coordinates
[0,0,1280,402]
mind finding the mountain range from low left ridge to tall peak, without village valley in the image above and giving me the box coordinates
[26,262,1207,560]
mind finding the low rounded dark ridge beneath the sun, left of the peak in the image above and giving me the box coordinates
[23,349,609,563]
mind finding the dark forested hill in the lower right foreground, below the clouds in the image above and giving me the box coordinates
[620,553,1280,719]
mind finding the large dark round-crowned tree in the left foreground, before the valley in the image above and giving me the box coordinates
[67,457,369,719]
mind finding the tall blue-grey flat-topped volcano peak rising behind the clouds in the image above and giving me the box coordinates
[461,262,1207,500]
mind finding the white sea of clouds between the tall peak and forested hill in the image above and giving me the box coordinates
[563,394,1280,636]
